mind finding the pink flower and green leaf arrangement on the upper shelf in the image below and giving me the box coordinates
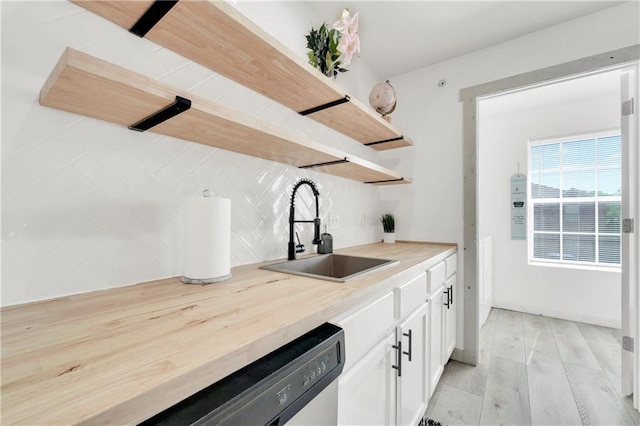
[305,9,360,78]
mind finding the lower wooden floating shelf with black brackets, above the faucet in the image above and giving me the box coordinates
[40,48,411,185]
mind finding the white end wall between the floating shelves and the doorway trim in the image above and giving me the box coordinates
[382,2,640,342]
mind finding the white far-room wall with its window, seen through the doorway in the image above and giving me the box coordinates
[477,70,622,328]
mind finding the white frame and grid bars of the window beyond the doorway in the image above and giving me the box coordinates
[526,129,622,272]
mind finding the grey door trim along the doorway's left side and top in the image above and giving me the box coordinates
[460,44,640,365]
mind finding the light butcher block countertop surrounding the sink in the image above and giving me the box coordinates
[0,242,456,425]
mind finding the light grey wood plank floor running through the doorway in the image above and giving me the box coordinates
[426,308,640,426]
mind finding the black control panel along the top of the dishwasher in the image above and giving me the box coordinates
[142,323,345,426]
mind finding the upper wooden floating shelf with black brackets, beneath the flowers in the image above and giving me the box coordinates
[72,0,413,151]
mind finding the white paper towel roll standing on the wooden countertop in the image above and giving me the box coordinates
[182,191,231,284]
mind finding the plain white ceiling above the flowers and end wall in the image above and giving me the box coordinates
[304,0,624,78]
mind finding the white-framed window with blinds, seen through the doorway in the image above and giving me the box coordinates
[528,132,622,268]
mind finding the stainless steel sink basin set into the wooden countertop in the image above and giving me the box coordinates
[260,254,398,283]
